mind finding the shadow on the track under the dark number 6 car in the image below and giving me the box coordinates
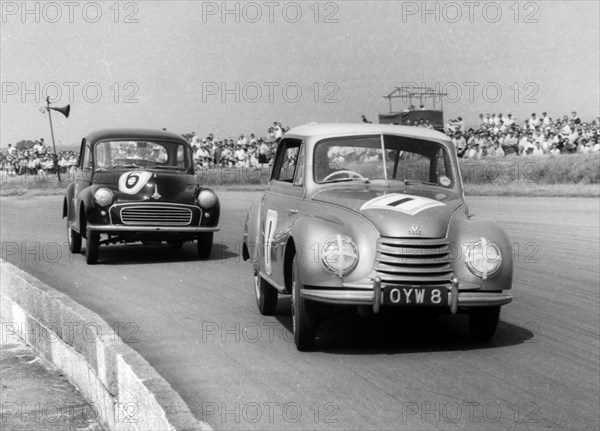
[84,243,238,265]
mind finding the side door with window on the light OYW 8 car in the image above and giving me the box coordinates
[261,138,305,286]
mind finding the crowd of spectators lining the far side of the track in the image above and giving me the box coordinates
[0,111,600,177]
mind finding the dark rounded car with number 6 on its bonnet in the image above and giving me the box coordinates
[63,129,220,264]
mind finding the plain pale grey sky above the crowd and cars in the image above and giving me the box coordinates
[0,1,600,149]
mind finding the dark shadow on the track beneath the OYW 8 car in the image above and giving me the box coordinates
[275,298,538,355]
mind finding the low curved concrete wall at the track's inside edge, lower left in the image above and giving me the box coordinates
[0,260,212,430]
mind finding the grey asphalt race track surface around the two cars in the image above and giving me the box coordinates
[0,192,600,430]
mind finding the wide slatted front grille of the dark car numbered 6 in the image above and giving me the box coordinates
[121,205,192,226]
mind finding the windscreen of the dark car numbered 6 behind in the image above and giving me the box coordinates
[94,140,191,170]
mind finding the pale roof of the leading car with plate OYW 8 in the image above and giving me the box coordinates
[286,123,450,141]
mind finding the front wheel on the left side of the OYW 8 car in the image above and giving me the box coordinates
[292,256,317,351]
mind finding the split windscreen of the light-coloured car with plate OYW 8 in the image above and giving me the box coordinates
[313,135,456,187]
